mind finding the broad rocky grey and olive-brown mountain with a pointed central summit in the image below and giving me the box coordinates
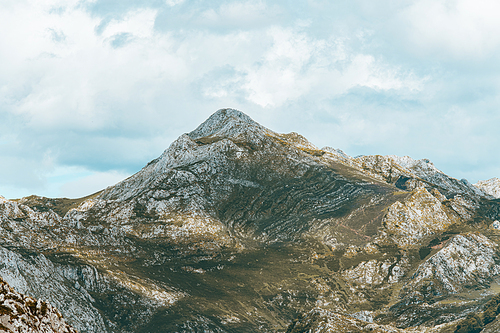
[0,109,500,332]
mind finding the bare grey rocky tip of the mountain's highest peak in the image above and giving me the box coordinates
[188,109,269,140]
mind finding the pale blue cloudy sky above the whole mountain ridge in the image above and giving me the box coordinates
[0,0,500,198]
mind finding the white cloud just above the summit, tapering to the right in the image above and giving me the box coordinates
[232,27,423,107]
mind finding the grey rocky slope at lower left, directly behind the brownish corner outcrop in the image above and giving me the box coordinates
[0,232,184,333]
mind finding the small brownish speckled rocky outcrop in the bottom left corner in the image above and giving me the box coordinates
[0,278,77,333]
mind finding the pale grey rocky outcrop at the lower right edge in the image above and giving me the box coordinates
[380,233,500,327]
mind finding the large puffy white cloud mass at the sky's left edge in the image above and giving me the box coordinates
[0,5,185,129]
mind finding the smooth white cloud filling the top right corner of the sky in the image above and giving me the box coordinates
[399,0,500,59]
